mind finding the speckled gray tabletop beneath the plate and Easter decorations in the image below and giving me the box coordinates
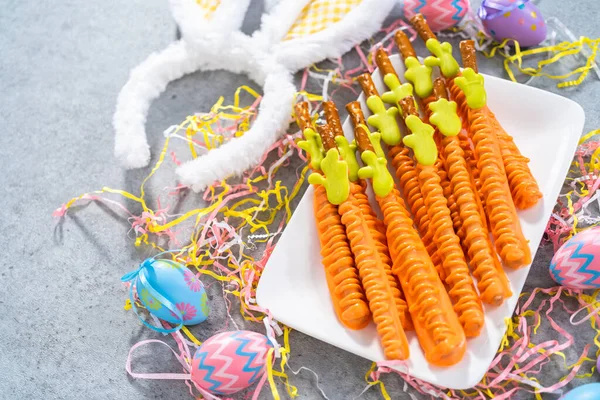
[0,0,600,400]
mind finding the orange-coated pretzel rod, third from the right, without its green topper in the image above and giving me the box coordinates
[434,82,512,305]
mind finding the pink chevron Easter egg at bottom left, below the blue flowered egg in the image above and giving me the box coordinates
[191,331,272,395]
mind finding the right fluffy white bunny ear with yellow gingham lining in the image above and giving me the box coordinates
[269,0,397,71]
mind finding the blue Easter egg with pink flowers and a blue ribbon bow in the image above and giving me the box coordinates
[135,259,209,325]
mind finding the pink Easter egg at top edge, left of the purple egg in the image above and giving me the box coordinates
[404,0,469,32]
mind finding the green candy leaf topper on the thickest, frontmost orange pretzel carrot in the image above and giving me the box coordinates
[355,124,394,197]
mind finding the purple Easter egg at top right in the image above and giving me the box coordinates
[479,0,547,47]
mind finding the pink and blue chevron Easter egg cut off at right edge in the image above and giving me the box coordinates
[550,227,600,289]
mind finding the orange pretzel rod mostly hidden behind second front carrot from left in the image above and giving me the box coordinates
[323,101,414,330]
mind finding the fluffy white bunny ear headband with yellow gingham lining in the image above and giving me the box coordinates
[113,0,396,191]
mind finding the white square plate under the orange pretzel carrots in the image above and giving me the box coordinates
[256,55,585,389]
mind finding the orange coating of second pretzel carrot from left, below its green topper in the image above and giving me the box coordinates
[339,183,409,360]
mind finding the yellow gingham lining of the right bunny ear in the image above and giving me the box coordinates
[284,0,362,40]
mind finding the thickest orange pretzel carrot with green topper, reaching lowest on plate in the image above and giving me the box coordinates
[355,115,465,366]
